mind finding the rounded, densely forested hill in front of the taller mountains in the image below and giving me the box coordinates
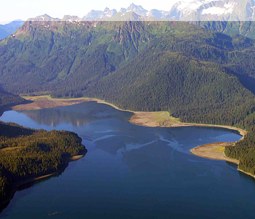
[85,51,255,125]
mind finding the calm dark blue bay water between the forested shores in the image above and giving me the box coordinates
[0,102,255,219]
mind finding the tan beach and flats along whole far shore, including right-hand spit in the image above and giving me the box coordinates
[12,95,250,178]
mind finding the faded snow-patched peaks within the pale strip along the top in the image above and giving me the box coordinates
[30,0,255,22]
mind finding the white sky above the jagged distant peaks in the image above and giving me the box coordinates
[0,0,177,23]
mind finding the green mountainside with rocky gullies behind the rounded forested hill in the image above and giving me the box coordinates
[0,22,255,96]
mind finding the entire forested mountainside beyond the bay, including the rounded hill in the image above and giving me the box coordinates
[0,21,255,176]
